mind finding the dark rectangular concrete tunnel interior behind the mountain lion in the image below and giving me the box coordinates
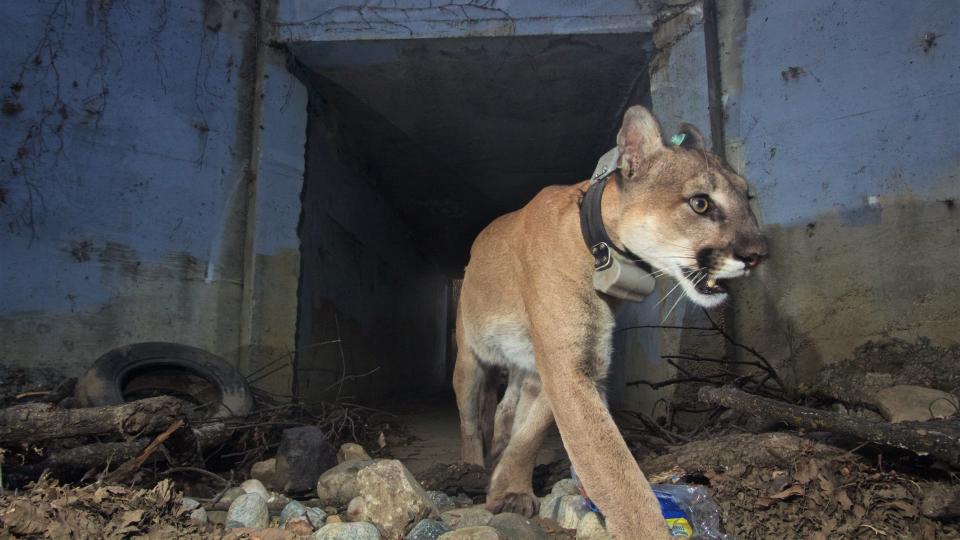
[290,33,652,408]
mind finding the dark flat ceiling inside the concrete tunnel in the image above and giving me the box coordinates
[289,34,650,272]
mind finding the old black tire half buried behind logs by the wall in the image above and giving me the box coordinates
[76,342,253,417]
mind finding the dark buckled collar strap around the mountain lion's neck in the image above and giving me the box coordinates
[580,148,652,272]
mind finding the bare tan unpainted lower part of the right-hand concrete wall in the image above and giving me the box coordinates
[734,200,960,383]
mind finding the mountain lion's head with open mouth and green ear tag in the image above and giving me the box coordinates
[616,106,767,307]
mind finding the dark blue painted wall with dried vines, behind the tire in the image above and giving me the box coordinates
[0,0,256,374]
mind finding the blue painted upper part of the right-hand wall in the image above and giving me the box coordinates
[736,0,960,225]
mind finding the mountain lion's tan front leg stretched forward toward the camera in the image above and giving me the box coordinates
[524,301,669,540]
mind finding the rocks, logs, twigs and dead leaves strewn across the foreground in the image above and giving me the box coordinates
[0,336,960,540]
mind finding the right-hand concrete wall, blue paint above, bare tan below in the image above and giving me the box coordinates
[720,0,960,388]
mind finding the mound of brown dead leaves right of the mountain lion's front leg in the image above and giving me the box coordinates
[641,432,960,539]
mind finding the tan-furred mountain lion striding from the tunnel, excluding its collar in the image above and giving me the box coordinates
[454,103,766,540]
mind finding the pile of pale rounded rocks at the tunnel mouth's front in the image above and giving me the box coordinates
[200,444,609,540]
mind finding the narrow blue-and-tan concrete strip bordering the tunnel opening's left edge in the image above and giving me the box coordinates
[238,47,307,397]
